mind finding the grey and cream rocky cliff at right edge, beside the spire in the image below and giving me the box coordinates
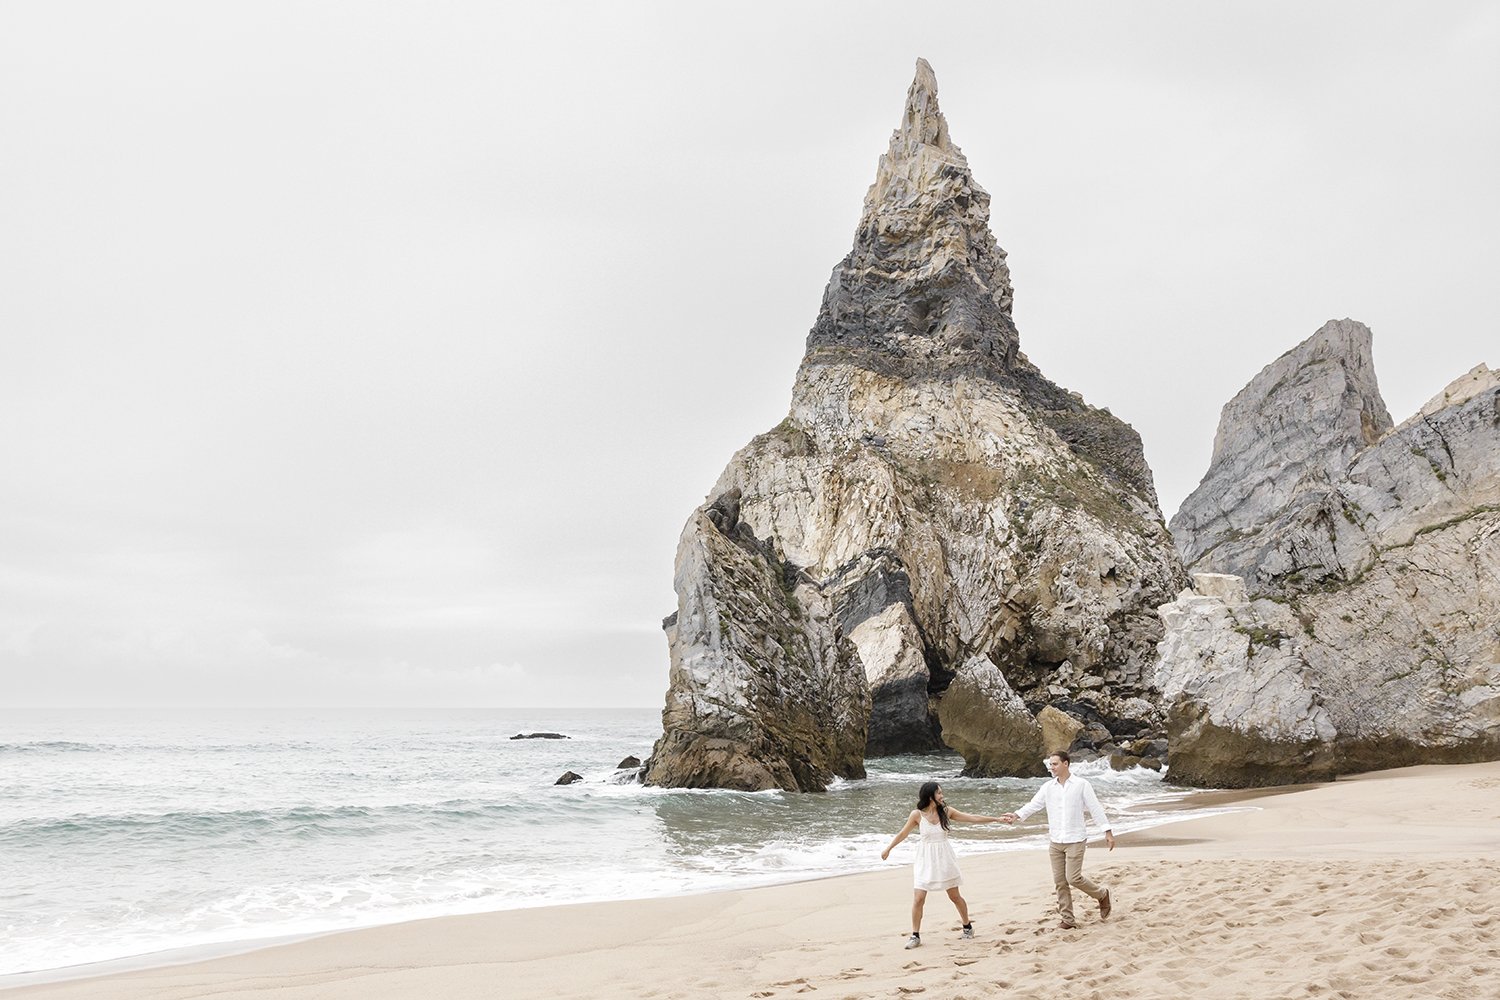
[1157,329,1500,786]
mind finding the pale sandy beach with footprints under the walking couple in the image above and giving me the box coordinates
[6,763,1500,1000]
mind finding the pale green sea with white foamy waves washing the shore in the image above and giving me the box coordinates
[0,709,1221,988]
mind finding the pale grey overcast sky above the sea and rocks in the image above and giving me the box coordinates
[0,0,1500,708]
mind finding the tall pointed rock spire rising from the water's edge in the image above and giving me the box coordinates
[647,61,1185,789]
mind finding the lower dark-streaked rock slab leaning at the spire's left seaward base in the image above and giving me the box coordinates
[647,492,870,790]
